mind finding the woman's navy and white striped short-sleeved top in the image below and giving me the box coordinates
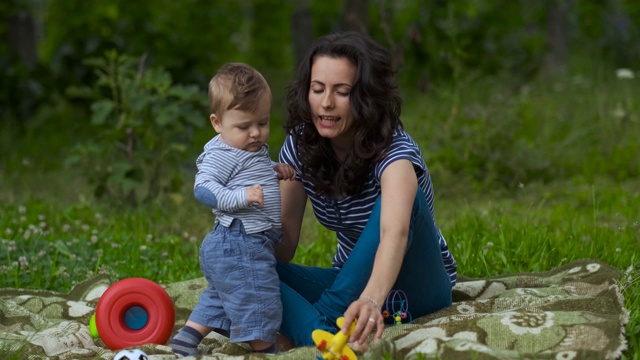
[280,129,457,286]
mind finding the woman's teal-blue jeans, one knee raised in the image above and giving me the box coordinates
[277,189,451,346]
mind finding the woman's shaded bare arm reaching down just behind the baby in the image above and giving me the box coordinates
[276,180,307,263]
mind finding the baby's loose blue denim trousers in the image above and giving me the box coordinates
[189,219,282,342]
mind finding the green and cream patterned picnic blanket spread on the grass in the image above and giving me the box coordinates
[0,260,629,360]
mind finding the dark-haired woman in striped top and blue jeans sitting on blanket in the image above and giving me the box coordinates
[276,32,456,346]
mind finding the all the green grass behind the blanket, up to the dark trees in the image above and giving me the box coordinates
[0,60,640,358]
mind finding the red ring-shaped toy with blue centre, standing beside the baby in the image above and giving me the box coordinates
[89,278,175,350]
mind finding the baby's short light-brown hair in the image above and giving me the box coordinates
[209,63,271,117]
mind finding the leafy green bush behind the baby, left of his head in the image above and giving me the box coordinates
[67,51,206,205]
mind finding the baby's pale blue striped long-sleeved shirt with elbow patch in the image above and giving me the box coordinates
[194,135,280,234]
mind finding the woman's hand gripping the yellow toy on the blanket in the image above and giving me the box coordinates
[342,296,384,345]
